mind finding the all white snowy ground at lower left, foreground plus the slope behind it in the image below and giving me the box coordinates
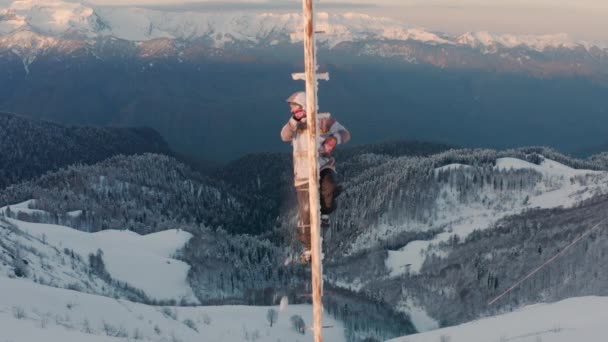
[0,211,345,342]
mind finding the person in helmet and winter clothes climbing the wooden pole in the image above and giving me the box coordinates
[281,92,350,263]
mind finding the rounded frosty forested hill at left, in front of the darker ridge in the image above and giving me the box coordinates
[0,154,265,234]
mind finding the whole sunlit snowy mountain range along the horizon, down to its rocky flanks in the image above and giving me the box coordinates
[0,0,608,74]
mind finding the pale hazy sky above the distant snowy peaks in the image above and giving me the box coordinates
[79,0,608,44]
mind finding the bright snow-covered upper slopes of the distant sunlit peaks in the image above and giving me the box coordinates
[0,0,591,51]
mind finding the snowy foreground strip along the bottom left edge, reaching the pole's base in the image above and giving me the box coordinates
[0,276,345,342]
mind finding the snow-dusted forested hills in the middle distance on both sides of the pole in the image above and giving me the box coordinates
[0,132,608,341]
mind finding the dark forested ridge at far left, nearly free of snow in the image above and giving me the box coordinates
[0,112,171,189]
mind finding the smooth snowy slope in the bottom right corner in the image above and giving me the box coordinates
[390,297,608,342]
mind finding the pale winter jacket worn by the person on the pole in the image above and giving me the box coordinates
[281,113,350,186]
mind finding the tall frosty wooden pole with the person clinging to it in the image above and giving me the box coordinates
[302,0,323,342]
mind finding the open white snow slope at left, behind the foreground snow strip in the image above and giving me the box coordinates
[0,206,198,303]
